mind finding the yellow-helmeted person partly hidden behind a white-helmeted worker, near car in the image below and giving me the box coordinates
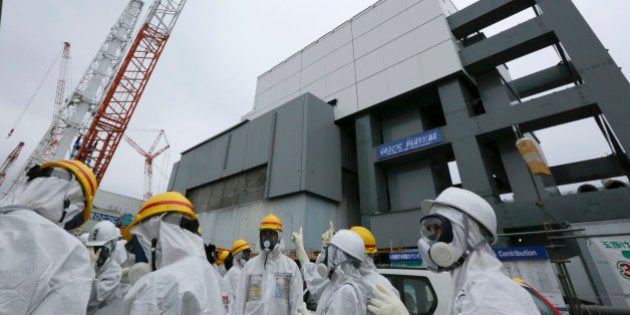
[350,226,400,302]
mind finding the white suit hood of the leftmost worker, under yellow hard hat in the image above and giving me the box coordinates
[0,177,85,228]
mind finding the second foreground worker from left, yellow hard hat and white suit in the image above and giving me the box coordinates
[120,192,230,314]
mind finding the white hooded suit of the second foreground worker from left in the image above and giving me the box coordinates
[121,214,230,314]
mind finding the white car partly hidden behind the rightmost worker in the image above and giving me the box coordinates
[378,268,453,315]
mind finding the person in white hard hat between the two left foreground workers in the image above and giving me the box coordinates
[85,221,122,314]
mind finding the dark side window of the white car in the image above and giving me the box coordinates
[384,275,437,315]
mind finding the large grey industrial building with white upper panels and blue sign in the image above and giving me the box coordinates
[169,0,630,306]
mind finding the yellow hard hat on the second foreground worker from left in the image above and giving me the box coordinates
[127,191,197,231]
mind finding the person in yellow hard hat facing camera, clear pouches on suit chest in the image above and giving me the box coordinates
[235,214,302,315]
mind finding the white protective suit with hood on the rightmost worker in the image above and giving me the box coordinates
[423,205,539,315]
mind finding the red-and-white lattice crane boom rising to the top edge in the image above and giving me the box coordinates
[75,0,186,182]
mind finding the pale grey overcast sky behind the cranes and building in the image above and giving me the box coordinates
[0,0,630,202]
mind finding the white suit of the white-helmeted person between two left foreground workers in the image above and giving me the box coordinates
[87,257,122,314]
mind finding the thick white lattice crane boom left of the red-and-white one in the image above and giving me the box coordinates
[9,0,144,190]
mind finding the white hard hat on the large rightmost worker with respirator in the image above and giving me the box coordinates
[420,187,497,244]
